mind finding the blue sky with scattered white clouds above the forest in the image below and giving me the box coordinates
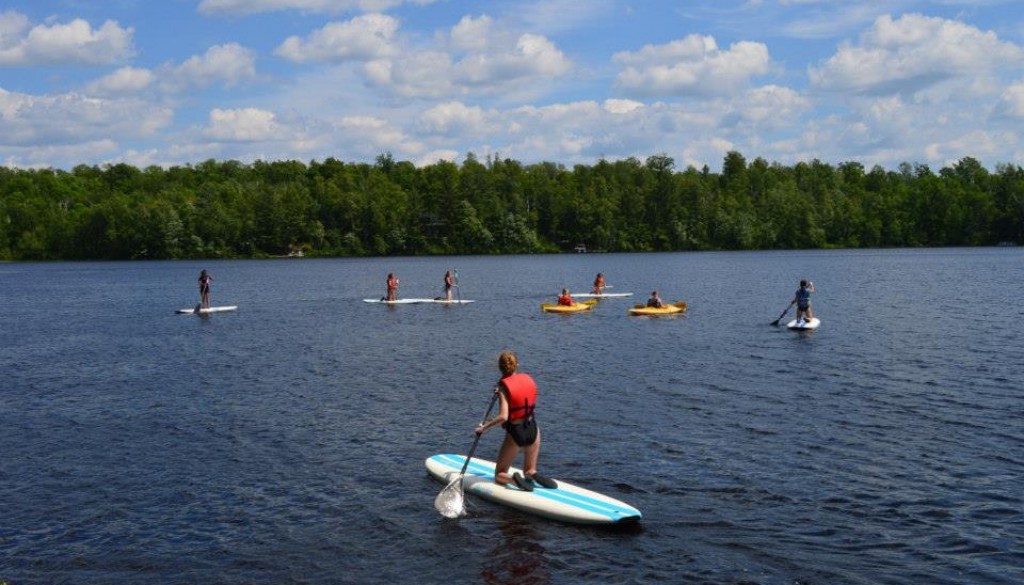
[0,0,1024,171]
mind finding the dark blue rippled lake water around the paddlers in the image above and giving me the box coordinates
[0,249,1024,585]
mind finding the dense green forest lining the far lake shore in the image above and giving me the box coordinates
[0,152,1024,260]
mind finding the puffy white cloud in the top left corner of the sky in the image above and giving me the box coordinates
[0,11,135,67]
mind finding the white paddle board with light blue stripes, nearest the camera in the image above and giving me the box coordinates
[426,453,640,525]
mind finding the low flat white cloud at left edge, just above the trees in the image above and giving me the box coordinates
[0,89,173,145]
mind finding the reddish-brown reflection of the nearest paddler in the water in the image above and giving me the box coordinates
[480,510,551,585]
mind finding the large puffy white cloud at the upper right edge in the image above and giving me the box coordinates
[809,14,1024,95]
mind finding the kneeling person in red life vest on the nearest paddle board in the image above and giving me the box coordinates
[474,351,558,492]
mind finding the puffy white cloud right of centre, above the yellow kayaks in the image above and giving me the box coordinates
[612,35,771,96]
